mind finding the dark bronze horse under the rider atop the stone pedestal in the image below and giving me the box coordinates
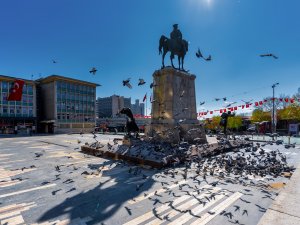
[158,35,189,71]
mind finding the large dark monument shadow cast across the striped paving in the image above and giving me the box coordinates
[38,161,155,224]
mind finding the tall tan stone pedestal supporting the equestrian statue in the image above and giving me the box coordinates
[145,67,207,143]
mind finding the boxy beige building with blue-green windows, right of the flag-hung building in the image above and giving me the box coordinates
[36,75,99,133]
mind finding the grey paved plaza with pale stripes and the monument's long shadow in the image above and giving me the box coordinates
[0,134,300,225]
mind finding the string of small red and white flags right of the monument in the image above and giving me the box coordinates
[198,98,300,117]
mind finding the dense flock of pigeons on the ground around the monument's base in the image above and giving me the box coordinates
[86,130,295,190]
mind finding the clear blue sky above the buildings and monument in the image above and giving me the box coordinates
[0,0,300,115]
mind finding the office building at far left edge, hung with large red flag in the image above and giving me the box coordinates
[0,75,37,134]
